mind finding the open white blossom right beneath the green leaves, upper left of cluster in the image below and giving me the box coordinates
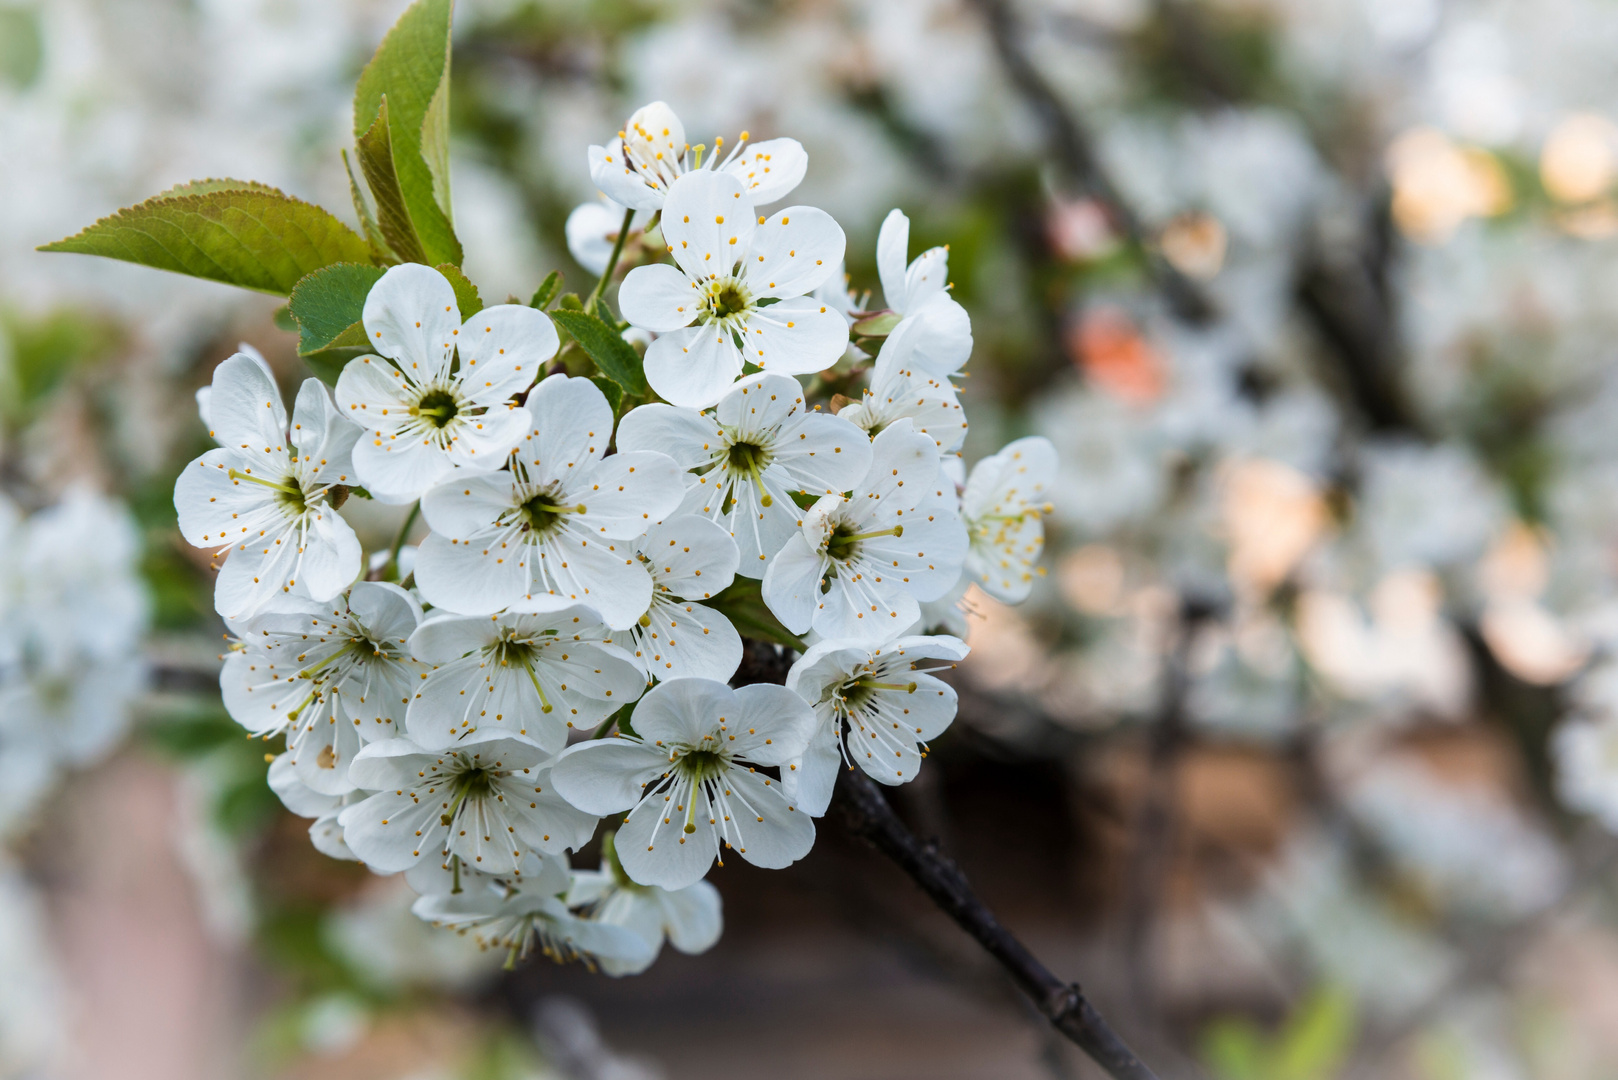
[337,262,560,504]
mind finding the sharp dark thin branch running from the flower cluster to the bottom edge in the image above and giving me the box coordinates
[832,769,1157,1080]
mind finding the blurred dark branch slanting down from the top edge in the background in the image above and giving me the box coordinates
[972,0,1215,322]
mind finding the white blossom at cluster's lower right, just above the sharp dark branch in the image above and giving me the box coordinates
[785,636,968,816]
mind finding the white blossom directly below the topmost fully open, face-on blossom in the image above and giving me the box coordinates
[618,372,870,578]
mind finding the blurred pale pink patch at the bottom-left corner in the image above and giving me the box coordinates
[37,750,257,1080]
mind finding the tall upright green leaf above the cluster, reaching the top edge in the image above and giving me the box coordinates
[354,0,461,266]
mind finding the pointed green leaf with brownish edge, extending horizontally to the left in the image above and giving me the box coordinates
[40,180,371,296]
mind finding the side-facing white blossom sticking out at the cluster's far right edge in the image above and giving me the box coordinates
[961,436,1057,604]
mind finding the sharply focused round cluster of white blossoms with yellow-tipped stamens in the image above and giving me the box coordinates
[175,102,1055,973]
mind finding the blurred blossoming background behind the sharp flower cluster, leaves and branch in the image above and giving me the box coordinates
[9,0,1618,1080]
